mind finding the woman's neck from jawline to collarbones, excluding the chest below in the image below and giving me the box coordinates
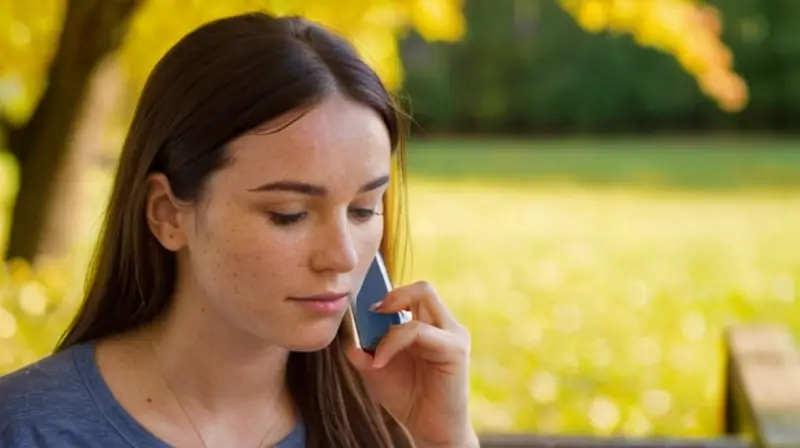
[141,288,288,412]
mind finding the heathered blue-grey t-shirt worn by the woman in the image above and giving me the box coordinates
[0,344,306,448]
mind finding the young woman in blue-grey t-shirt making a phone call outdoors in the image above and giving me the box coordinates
[0,9,478,448]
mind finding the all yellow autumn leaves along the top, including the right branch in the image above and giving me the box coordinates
[0,0,748,126]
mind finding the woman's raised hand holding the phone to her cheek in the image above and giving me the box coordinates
[348,282,479,448]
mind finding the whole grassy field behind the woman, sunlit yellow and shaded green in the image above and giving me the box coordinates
[0,140,800,436]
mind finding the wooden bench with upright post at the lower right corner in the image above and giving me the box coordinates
[481,325,800,448]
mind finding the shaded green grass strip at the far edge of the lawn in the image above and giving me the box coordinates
[409,138,800,189]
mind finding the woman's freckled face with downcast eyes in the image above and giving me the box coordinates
[180,95,391,351]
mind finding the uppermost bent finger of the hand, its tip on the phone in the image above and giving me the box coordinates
[373,282,457,328]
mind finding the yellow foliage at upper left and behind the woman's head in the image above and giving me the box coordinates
[0,0,465,127]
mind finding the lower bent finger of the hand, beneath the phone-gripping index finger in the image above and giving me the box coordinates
[372,320,469,369]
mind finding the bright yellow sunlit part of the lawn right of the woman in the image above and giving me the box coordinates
[411,179,800,434]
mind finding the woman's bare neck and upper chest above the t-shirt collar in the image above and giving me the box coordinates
[96,288,297,446]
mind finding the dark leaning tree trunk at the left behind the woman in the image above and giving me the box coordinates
[5,0,142,261]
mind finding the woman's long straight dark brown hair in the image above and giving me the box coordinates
[56,13,413,448]
